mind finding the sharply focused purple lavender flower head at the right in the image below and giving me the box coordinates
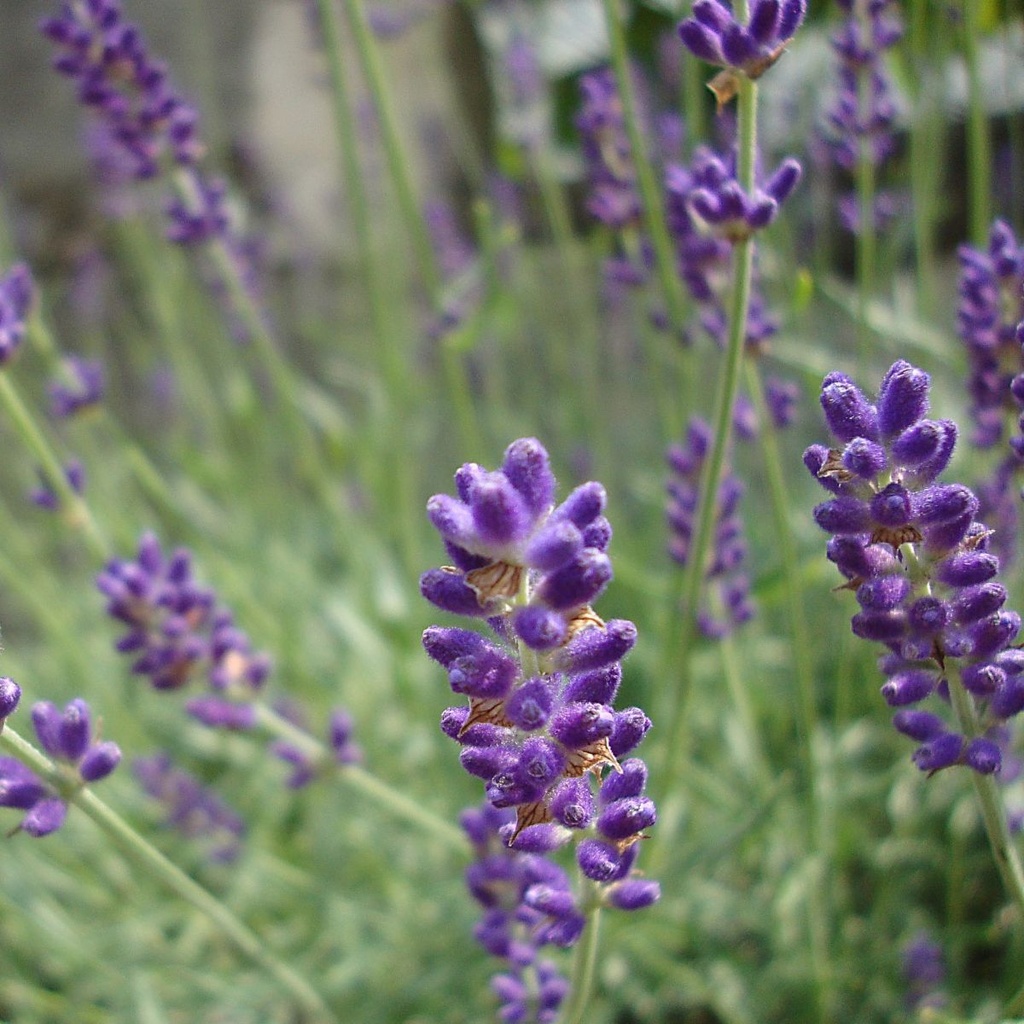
[804,360,1024,773]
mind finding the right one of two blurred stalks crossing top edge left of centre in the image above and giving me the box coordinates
[337,0,442,299]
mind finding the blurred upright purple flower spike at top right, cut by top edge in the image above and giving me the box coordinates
[824,0,903,232]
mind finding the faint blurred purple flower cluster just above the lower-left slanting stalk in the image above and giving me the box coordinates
[132,754,246,863]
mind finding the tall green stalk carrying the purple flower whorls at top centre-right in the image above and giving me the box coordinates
[659,78,757,790]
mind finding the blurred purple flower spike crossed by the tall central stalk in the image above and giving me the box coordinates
[668,417,754,637]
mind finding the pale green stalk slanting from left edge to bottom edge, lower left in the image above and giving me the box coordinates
[0,725,339,1024]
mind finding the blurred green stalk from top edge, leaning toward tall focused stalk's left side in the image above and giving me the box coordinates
[602,0,686,332]
